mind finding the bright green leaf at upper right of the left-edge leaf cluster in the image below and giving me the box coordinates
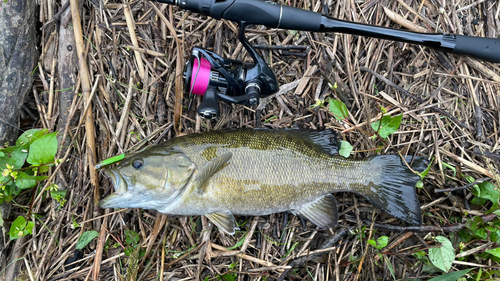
[27,132,57,165]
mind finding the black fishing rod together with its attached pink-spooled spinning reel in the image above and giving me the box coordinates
[155,0,500,118]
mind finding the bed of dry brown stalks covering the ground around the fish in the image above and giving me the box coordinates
[1,0,500,280]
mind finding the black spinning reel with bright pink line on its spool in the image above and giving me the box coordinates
[184,22,278,119]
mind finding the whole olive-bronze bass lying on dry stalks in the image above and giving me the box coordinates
[99,129,426,234]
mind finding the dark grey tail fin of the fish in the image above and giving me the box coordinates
[363,155,426,225]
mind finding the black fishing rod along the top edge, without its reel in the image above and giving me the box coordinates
[158,0,500,62]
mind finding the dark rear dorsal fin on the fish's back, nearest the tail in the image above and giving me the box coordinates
[284,128,340,155]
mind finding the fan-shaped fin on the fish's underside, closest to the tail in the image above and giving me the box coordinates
[295,194,339,229]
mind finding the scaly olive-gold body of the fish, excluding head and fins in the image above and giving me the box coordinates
[168,130,381,215]
